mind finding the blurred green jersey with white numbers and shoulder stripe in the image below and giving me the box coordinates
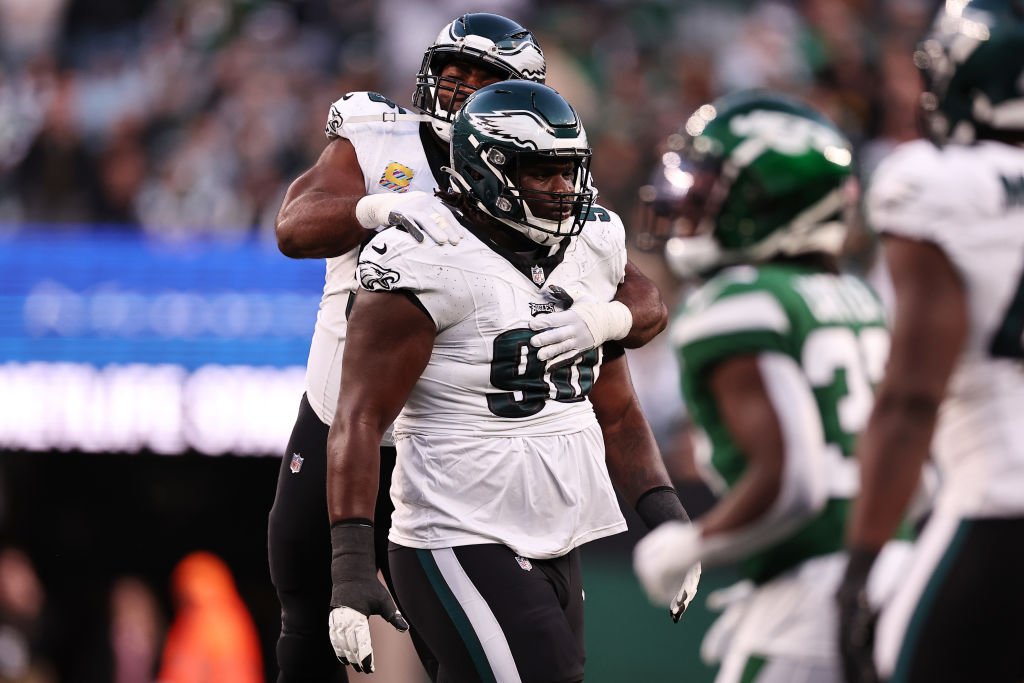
[671,264,889,583]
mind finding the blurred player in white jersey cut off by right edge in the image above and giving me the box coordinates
[839,0,1024,683]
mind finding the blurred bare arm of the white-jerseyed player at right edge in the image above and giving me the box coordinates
[847,237,968,551]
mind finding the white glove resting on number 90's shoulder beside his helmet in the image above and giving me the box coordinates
[355,191,464,245]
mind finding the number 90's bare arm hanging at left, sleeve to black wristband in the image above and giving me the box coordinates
[327,291,435,523]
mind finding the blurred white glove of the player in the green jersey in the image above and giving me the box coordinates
[633,521,701,609]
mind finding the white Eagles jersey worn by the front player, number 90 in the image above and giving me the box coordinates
[357,208,626,558]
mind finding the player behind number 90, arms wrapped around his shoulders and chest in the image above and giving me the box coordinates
[268,13,666,683]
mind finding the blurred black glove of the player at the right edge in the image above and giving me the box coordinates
[836,549,879,683]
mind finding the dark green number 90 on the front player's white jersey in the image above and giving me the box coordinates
[487,328,600,418]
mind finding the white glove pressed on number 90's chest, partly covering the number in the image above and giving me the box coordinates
[529,301,633,364]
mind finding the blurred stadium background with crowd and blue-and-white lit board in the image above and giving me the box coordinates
[0,0,930,683]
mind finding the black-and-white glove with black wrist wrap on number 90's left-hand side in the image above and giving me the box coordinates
[329,520,409,674]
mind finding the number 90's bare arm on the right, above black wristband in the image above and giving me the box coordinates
[590,355,672,507]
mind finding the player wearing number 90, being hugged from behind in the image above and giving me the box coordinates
[328,81,697,683]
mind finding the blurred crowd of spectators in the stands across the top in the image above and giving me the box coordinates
[0,0,930,240]
